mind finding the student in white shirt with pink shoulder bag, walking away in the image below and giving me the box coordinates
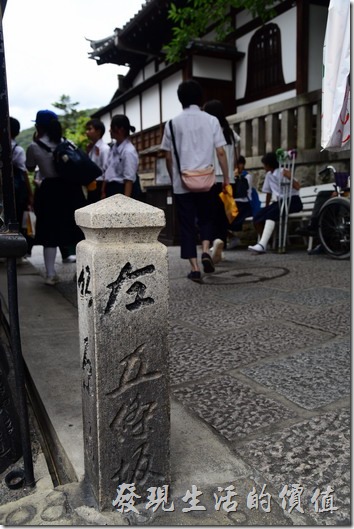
[161,79,229,283]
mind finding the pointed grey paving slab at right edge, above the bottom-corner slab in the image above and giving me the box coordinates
[241,341,351,410]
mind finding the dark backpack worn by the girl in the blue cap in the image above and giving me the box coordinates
[36,138,102,186]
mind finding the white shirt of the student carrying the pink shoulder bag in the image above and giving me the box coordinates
[161,105,226,194]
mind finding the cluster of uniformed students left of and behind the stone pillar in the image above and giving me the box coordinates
[10,110,139,286]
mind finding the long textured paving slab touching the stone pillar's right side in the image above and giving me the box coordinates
[169,318,332,384]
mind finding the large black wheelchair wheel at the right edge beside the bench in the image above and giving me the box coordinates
[318,197,350,259]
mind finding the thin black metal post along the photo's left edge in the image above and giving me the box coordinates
[0,0,35,487]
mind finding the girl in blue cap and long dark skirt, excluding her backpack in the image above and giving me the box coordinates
[26,110,87,286]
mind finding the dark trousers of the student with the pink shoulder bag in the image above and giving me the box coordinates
[174,186,215,259]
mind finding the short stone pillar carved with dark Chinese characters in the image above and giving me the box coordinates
[75,195,170,510]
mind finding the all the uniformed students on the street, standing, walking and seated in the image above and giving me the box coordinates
[11,79,302,285]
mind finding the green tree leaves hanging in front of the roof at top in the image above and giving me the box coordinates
[164,0,274,63]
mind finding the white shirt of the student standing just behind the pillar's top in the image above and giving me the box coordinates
[104,138,139,184]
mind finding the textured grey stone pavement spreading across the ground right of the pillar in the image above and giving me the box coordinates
[0,247,351,526]
